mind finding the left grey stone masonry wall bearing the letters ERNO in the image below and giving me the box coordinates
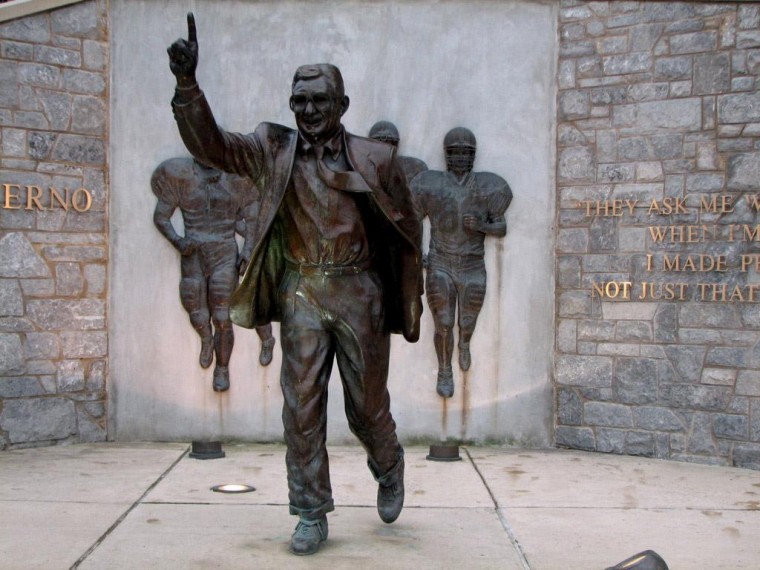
[0,0,108,449]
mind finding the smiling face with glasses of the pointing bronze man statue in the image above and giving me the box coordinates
[290,75,348,144]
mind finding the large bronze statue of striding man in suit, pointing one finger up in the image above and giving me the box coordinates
[168,14,422,554]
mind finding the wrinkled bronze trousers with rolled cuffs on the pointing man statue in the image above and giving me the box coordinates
[279,269,403,520]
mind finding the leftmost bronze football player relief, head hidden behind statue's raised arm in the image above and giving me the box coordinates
[150,157,275,392]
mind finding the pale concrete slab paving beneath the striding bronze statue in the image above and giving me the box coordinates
[0,444,760,570]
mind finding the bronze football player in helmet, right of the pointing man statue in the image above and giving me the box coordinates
[411,127,512,398]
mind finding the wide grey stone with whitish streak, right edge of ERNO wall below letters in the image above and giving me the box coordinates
[27,299,105,331]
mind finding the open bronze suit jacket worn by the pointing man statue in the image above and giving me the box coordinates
[172,88,423,342]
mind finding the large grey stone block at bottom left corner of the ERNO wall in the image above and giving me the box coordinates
[0,397,77,444]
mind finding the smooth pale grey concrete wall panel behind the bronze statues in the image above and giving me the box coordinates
[109,0,558,445]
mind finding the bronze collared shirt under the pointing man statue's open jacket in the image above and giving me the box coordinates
[278,129,371,265]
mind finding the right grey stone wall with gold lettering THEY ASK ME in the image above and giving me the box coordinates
[555,0,760,469]
